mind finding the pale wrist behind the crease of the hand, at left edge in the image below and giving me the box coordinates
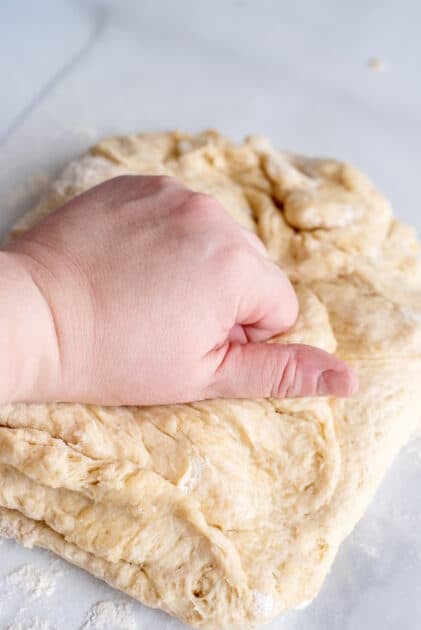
[0,251,60,404]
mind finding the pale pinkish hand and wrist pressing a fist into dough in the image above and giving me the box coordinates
[0,176,357,405]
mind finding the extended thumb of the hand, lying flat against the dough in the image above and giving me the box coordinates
[212,343,358,398]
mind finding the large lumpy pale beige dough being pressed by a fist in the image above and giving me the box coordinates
[0,131,421,630]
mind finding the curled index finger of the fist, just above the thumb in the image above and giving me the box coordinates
[235,256,298,342]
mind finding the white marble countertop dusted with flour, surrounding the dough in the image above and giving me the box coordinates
[0,0,421,630]
